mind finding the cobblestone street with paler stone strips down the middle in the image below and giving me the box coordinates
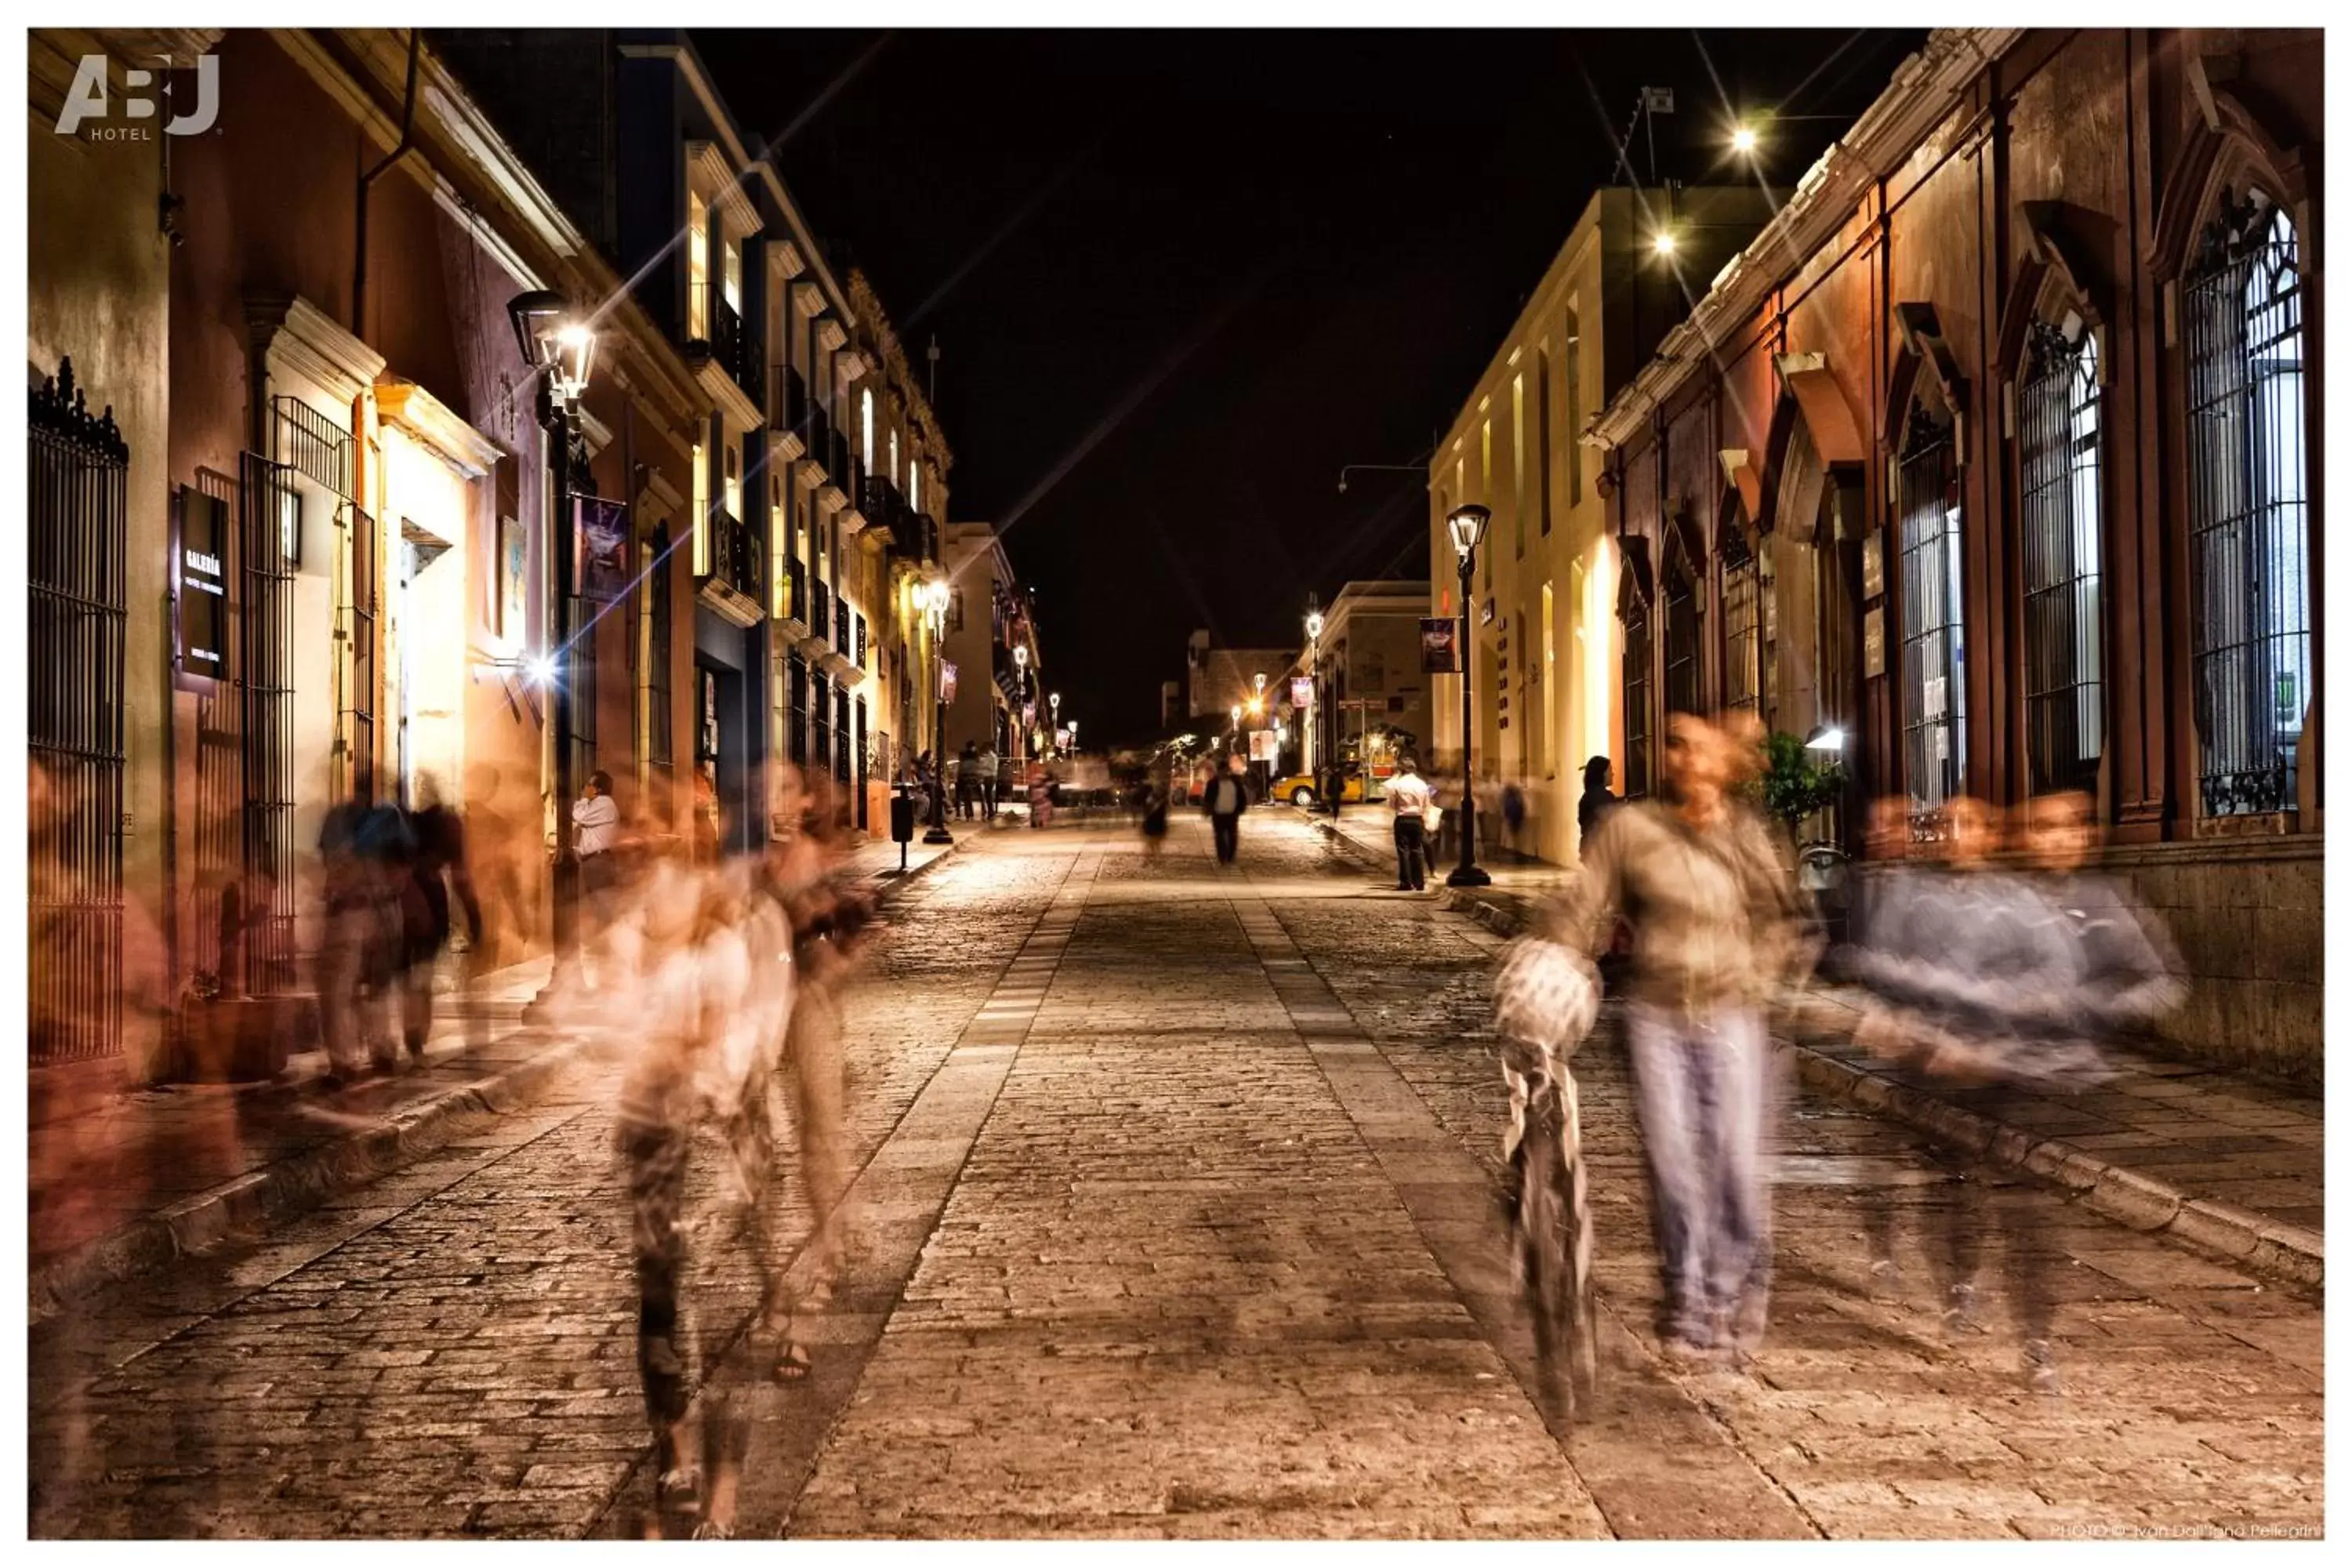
[28,808,2321,1537]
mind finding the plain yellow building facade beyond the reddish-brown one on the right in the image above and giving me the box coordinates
[1423,186,1771,862]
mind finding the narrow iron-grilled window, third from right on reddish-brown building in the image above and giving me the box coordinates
[1898,407,1966,820]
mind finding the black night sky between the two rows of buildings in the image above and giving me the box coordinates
[694,31,1924,743]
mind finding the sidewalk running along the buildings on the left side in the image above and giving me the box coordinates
[26,822,978,1323]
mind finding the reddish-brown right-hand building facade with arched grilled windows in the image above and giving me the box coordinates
[1592,28,2324,1081]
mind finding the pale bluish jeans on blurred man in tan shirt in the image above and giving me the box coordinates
[1625,1001,1771,1345]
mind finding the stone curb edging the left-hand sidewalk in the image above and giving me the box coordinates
[26,841,960,1326]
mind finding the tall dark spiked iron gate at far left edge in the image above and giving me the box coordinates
[26,360,129,1067]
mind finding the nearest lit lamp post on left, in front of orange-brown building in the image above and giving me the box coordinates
[506,289,595,1022]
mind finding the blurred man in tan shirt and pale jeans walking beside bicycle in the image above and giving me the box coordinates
[1545,713,1799,1359]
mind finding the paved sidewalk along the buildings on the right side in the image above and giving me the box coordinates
[1310,813,2326,1286]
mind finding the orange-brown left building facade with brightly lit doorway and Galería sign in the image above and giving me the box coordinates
[28,31,706,1100]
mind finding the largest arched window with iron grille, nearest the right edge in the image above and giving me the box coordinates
[2180,191,2314,815]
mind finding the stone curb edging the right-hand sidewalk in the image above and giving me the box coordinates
[1312,820,2326,1286]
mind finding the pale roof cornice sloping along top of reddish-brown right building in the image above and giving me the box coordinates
[1583,28,2025,449]
